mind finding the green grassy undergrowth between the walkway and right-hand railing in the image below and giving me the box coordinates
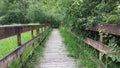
[60,27,120,68]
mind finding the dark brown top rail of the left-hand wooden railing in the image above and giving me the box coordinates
[0,24,46,39]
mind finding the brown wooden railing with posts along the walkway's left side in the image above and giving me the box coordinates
[0,25,50,68]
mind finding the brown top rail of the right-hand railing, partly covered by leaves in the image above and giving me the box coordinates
[86,24,120,35]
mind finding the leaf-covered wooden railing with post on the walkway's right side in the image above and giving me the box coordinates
[83,24,120,61]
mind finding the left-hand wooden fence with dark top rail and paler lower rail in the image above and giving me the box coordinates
[0,25,48,68]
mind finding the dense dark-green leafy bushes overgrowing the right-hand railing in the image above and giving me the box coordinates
[58,0,120,68]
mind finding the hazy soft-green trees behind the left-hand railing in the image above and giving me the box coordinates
[0,0,62,24]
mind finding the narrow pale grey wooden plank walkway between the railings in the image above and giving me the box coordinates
[36,29,74,68]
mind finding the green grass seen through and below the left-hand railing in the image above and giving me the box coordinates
[0,26,51,68]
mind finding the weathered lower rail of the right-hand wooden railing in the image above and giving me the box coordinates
[68,30,105,68]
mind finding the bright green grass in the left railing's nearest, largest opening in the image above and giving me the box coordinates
[0,36,17,58]
